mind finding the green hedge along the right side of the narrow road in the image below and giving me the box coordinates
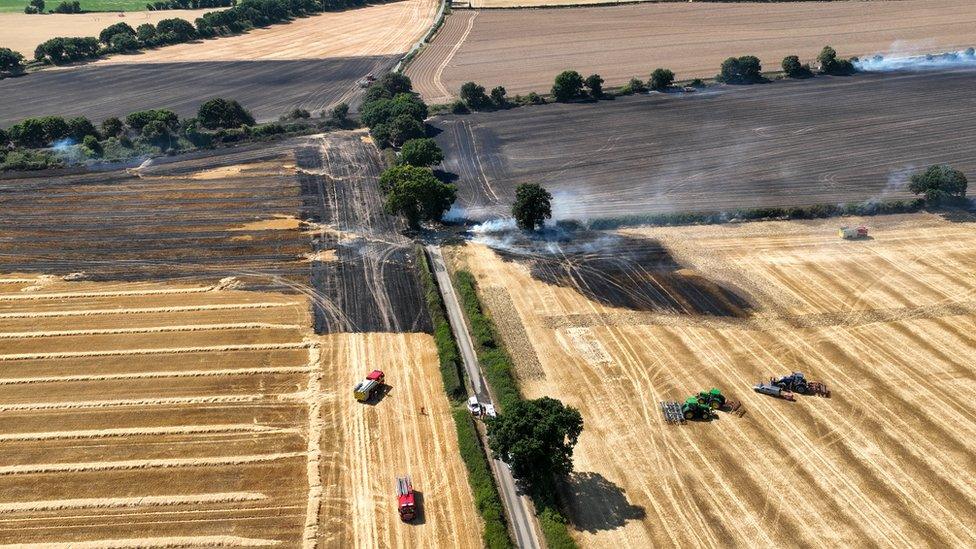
[454,271,577,549]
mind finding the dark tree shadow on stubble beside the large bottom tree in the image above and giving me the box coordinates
[562,472,647,534]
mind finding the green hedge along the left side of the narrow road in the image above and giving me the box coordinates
[416,246,514,549]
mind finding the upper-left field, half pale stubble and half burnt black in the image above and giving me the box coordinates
[0,0,436,126]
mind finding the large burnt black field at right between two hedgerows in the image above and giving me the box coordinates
[433,70,976,219]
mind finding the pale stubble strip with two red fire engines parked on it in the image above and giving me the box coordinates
[319,333,482,548]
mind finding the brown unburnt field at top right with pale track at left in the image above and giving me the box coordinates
[407,0,976,103]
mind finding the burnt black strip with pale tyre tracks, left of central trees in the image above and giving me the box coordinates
[295,134,432,333]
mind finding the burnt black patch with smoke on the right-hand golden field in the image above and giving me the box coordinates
[486,231,752,317]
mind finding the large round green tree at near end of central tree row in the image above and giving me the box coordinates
[380,166,457,229]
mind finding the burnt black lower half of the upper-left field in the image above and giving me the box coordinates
[0,55,399,127]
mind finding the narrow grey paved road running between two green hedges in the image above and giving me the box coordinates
[427,244,543,549]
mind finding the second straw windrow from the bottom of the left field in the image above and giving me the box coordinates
[0,492,268,514]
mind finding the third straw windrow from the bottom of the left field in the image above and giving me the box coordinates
[0,452,304,476]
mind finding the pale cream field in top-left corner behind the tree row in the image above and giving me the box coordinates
[0,10,215,54]
